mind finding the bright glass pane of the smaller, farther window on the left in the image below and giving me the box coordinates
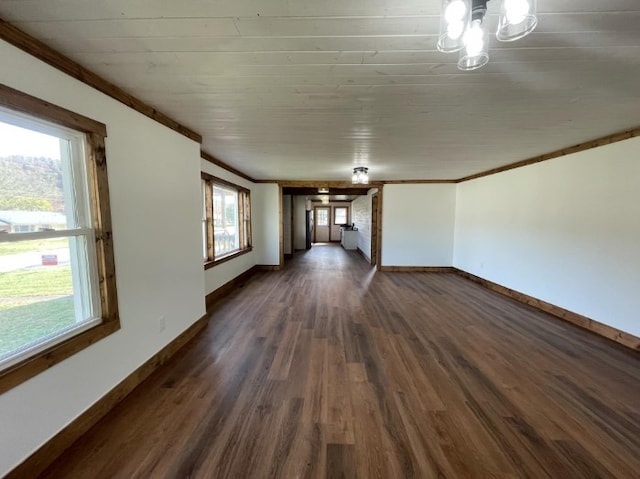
[213,185,240,257]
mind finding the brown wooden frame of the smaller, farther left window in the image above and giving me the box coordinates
[200,172,253,269]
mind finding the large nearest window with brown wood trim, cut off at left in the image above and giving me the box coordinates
[0,85,119,392]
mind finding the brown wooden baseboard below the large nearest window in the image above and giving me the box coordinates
[6,315,208,479]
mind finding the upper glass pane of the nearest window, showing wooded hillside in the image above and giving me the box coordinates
[0,122,76,233]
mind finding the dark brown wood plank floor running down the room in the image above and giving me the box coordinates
[45,245,640,479]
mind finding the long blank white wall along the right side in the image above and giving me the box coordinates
[454,138,640,335]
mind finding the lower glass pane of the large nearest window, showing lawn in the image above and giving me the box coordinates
[0,238,80,360]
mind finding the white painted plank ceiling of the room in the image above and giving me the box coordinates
[0,0,640,181]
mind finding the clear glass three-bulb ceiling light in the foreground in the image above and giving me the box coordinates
[438,0,538,71]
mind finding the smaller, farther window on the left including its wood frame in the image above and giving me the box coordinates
[202,173,251,266]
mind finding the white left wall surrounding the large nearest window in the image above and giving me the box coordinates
[0,41,205,476]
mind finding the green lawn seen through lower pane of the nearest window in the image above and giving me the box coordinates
[0,266,75,357]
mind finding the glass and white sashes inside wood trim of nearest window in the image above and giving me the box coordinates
[0,110,101,372]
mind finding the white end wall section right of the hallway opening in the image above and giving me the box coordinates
[381,184,456,266]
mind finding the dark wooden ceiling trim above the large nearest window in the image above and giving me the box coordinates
[0,19,202,143]
